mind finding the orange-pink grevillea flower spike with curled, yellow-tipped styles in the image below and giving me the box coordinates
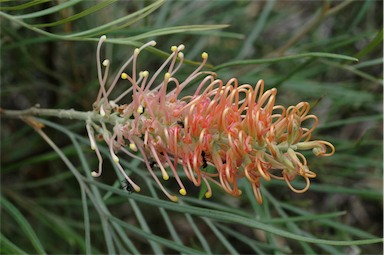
[87,36,335,204]
